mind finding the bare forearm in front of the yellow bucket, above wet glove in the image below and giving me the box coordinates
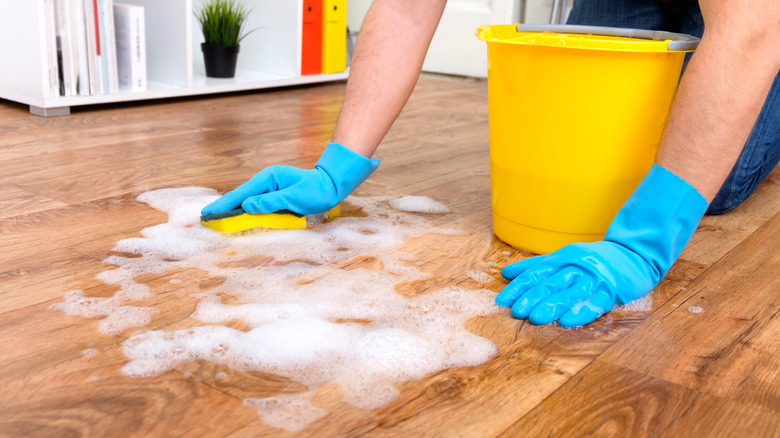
[656,0,780,202]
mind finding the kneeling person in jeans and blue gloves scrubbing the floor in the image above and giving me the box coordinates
[203,0,780,327]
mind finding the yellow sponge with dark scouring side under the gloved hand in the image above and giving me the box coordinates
[200,205,340,234]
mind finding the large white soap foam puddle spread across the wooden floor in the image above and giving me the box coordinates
[51,187,499,430]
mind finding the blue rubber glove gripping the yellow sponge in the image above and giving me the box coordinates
[201,143,379,216]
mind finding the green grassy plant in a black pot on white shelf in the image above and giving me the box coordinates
[195,0,251,78]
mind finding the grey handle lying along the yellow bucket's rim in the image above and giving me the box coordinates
[517,24,701,52]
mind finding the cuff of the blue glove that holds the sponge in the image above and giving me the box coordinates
[314,143,379,202]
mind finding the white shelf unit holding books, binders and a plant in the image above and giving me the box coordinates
[0,0,347,116]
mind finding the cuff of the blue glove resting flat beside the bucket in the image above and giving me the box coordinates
[604,164,709,281]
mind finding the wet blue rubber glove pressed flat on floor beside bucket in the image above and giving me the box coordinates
[496,164,708,327]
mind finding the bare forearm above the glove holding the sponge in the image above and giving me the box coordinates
[333,0,446,157]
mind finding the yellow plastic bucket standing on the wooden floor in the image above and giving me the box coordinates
[477,25,698,254]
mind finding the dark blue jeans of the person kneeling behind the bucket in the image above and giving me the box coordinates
[568,0,780,214]
